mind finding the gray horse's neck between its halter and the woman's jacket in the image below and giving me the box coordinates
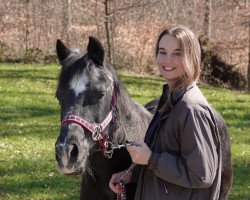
[116,84,152,141]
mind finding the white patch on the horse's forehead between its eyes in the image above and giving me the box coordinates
[70,74,88,96]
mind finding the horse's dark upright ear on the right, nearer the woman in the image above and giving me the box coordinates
[87,36,104,65]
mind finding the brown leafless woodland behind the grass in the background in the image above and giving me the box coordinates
[0,0,250,90]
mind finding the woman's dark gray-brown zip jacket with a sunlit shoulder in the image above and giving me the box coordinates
[135,84,222,200]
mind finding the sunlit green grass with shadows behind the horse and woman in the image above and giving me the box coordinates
[0,64,250,200]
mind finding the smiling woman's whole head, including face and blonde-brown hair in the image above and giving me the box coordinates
[155,25,201,90]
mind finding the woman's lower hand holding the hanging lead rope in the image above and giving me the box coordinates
[109,170,132,193]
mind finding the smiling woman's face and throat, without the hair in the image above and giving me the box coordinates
[156,35,184,89]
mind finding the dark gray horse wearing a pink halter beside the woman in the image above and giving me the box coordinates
[55,37,232,200]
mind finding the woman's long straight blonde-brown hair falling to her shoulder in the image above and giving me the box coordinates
[155,25,201,87]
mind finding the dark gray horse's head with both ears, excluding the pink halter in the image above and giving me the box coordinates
[56,37,116,174]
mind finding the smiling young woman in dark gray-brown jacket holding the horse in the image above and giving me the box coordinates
[110,26,221,200]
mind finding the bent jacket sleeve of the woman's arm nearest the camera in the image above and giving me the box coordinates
[148,110,218,188]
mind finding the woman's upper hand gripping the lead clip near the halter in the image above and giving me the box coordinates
[127,142,152,165]
